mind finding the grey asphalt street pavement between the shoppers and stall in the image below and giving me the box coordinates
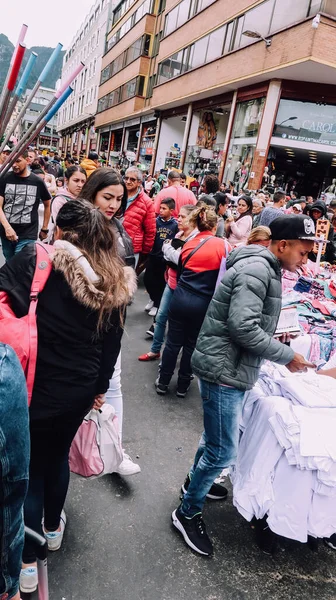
[14,278,336,600]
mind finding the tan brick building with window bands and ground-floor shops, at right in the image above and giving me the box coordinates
[96,0,336,196]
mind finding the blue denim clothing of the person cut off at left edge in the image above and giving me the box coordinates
[0,344,29,598]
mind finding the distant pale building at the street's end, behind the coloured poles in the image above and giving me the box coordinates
[18,86,59,150]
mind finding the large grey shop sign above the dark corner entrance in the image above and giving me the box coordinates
[273,100,336,146]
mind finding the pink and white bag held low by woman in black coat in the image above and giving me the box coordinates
[69,403,123,477]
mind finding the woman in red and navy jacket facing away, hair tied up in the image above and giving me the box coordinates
[155,204,231,398]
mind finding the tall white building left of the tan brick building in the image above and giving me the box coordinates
[57,0,112,155]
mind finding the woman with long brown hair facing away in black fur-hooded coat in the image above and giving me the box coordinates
[0,200,130,592]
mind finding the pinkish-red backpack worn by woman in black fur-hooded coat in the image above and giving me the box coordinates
[0,242,54,406]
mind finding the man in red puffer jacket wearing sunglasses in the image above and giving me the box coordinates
[123,167,156,272]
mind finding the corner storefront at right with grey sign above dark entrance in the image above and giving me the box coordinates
[266,98,336,198]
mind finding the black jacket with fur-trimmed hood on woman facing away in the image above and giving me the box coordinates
[0,243,122,421]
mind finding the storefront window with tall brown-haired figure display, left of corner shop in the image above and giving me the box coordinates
[184,104,231,177]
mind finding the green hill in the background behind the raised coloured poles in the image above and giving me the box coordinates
[0,33,64,91]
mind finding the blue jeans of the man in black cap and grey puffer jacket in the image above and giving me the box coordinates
[181,379,244,517]
